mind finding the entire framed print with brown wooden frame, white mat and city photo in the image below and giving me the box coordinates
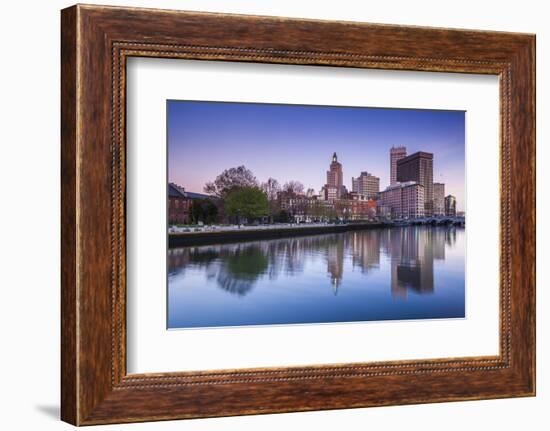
[61,5,535,425]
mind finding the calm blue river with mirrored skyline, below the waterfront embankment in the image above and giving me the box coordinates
[168,226,465,328]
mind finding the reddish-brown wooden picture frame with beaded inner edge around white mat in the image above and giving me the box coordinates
[61,5,535,425]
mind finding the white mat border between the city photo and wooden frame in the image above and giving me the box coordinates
[127,58,500,373]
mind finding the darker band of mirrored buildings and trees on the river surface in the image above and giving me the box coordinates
[168,226,457,298]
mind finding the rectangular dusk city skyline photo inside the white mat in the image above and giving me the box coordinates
[166,100,466,329]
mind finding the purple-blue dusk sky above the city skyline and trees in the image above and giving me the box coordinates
[167,100,465,211]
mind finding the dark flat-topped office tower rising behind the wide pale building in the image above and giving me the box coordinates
[396,151,434,217]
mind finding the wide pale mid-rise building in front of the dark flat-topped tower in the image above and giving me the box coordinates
[378,181,425,218]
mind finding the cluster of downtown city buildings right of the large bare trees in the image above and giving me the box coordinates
[268,147,456,222]
